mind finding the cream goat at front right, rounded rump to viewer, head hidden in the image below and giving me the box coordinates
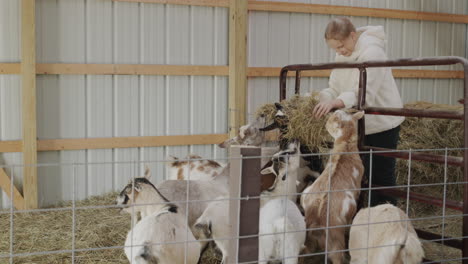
[349,204,424,264]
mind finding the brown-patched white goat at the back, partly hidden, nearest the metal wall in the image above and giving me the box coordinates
[168,155,224,180]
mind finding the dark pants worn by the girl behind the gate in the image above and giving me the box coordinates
[361,126,400,206]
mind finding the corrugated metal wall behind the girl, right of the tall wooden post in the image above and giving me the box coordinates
[248,0,468,114]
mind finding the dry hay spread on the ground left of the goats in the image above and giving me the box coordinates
[0,193,130,264]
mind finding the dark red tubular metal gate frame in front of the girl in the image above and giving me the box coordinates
[280,56,468,264]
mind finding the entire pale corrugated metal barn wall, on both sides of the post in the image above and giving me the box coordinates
[0,0,467,207]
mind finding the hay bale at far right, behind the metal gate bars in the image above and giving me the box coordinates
[397,102,463,200]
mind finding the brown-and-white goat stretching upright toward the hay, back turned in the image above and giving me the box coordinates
[301,110,364,264]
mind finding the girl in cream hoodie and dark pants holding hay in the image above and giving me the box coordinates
[312,17,404,206]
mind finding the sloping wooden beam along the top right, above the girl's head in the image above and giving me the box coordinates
[249,0,468,24]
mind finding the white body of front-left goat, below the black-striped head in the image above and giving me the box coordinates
[125,201,200,264]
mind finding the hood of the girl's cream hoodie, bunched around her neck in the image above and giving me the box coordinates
[336,26,387,62]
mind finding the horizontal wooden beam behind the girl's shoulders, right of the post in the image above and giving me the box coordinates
[248,67,464,79]
